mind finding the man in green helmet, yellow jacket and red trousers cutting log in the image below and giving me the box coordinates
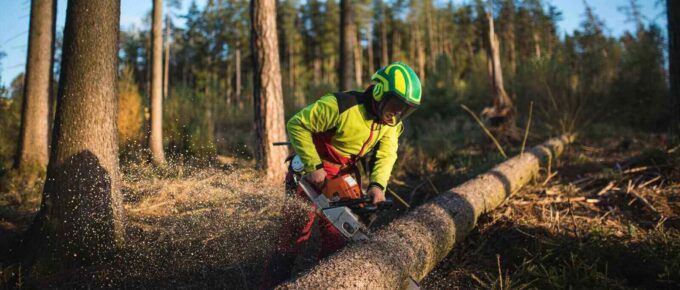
[260,62,421,289]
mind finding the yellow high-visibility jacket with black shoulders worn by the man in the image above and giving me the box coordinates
[287,92,404,189]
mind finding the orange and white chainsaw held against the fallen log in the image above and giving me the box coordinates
[290,155,393,241]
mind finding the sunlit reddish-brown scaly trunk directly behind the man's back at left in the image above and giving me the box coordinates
[250,0,287,183]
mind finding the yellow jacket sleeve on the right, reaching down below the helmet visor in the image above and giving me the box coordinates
[370,123,404,190]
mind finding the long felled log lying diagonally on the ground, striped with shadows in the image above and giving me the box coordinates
[279,135,573,289]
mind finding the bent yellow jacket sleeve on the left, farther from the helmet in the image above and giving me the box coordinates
[286,95,340,172]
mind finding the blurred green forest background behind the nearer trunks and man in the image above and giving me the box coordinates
[0,0,671,169]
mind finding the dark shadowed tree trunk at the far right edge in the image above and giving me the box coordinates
[666,0,680,141]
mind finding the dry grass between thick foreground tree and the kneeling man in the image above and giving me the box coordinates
[0,160,309,289]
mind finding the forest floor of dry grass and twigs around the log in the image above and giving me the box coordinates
[0,135,680,289]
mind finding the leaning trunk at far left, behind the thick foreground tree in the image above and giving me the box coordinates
[14,0,57,180]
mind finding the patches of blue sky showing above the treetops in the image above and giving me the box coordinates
[0,0,671,86]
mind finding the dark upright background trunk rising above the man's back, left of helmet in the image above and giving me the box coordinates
[338,0,356,91]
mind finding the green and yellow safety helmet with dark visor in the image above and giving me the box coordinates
[371,62,421,126]
